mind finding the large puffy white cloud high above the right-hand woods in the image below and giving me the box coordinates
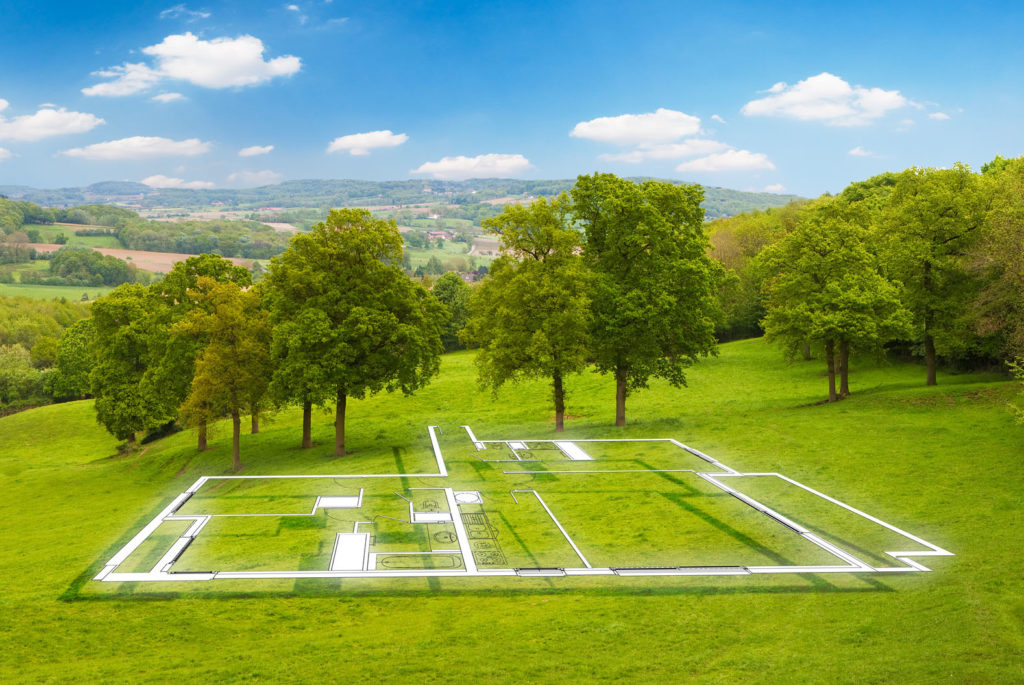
[741,72,913,126]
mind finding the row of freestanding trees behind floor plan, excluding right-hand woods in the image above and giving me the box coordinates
[46,174,721,468]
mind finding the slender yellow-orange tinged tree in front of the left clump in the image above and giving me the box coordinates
[171,276,270,471]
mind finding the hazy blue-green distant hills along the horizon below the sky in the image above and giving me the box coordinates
[0,178,800,219]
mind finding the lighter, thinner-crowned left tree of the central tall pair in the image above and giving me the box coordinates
[460,194,591,433]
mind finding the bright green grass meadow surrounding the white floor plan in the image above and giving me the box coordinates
[0,341,1024,683]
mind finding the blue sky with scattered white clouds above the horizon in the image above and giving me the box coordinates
[0,0,1024,196]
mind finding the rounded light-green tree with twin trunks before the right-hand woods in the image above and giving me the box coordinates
[761,198,909,401]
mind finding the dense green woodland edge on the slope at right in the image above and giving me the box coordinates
[712,158,1024,401]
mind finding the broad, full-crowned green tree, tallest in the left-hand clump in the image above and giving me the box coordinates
[265,209,447,457]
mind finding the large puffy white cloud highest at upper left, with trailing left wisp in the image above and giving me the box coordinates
[82,32,302,96]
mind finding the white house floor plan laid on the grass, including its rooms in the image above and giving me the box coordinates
[94,426,952,583]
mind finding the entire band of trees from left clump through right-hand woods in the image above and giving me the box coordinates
[39,158,1024,466]
